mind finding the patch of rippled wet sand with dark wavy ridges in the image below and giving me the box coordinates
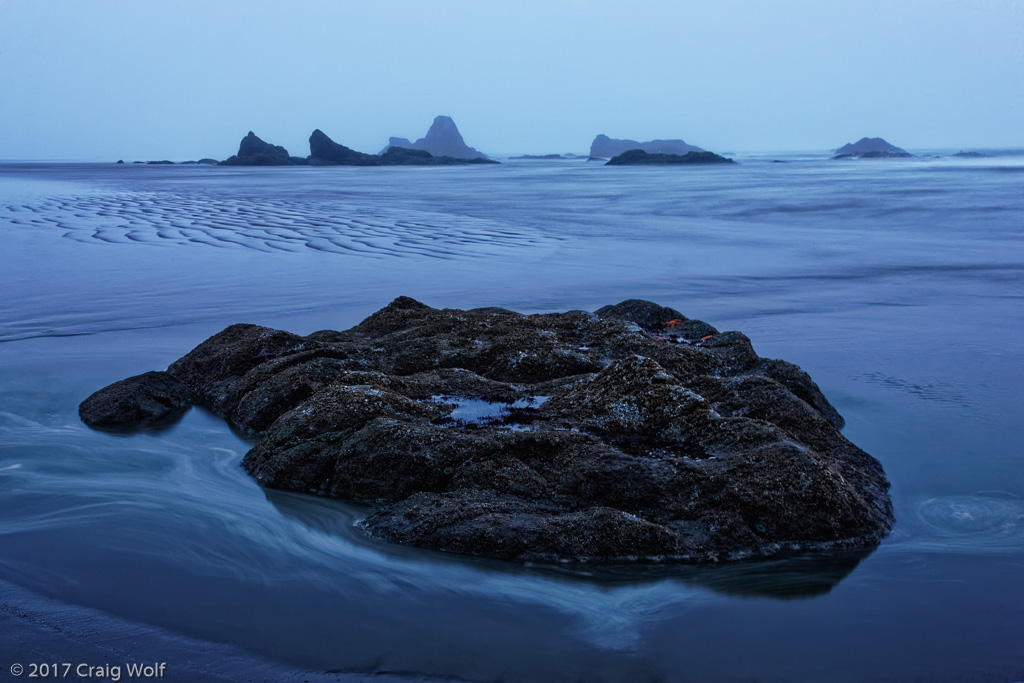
[2,194,557,259]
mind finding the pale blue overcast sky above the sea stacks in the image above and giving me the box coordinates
[0,0,1024,161]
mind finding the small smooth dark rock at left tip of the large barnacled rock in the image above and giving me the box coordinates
[78,372,198,428]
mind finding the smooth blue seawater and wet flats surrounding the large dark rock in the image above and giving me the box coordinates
[0,155,1024,683]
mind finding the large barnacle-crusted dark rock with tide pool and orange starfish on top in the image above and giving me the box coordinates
[82,297,892,562]
